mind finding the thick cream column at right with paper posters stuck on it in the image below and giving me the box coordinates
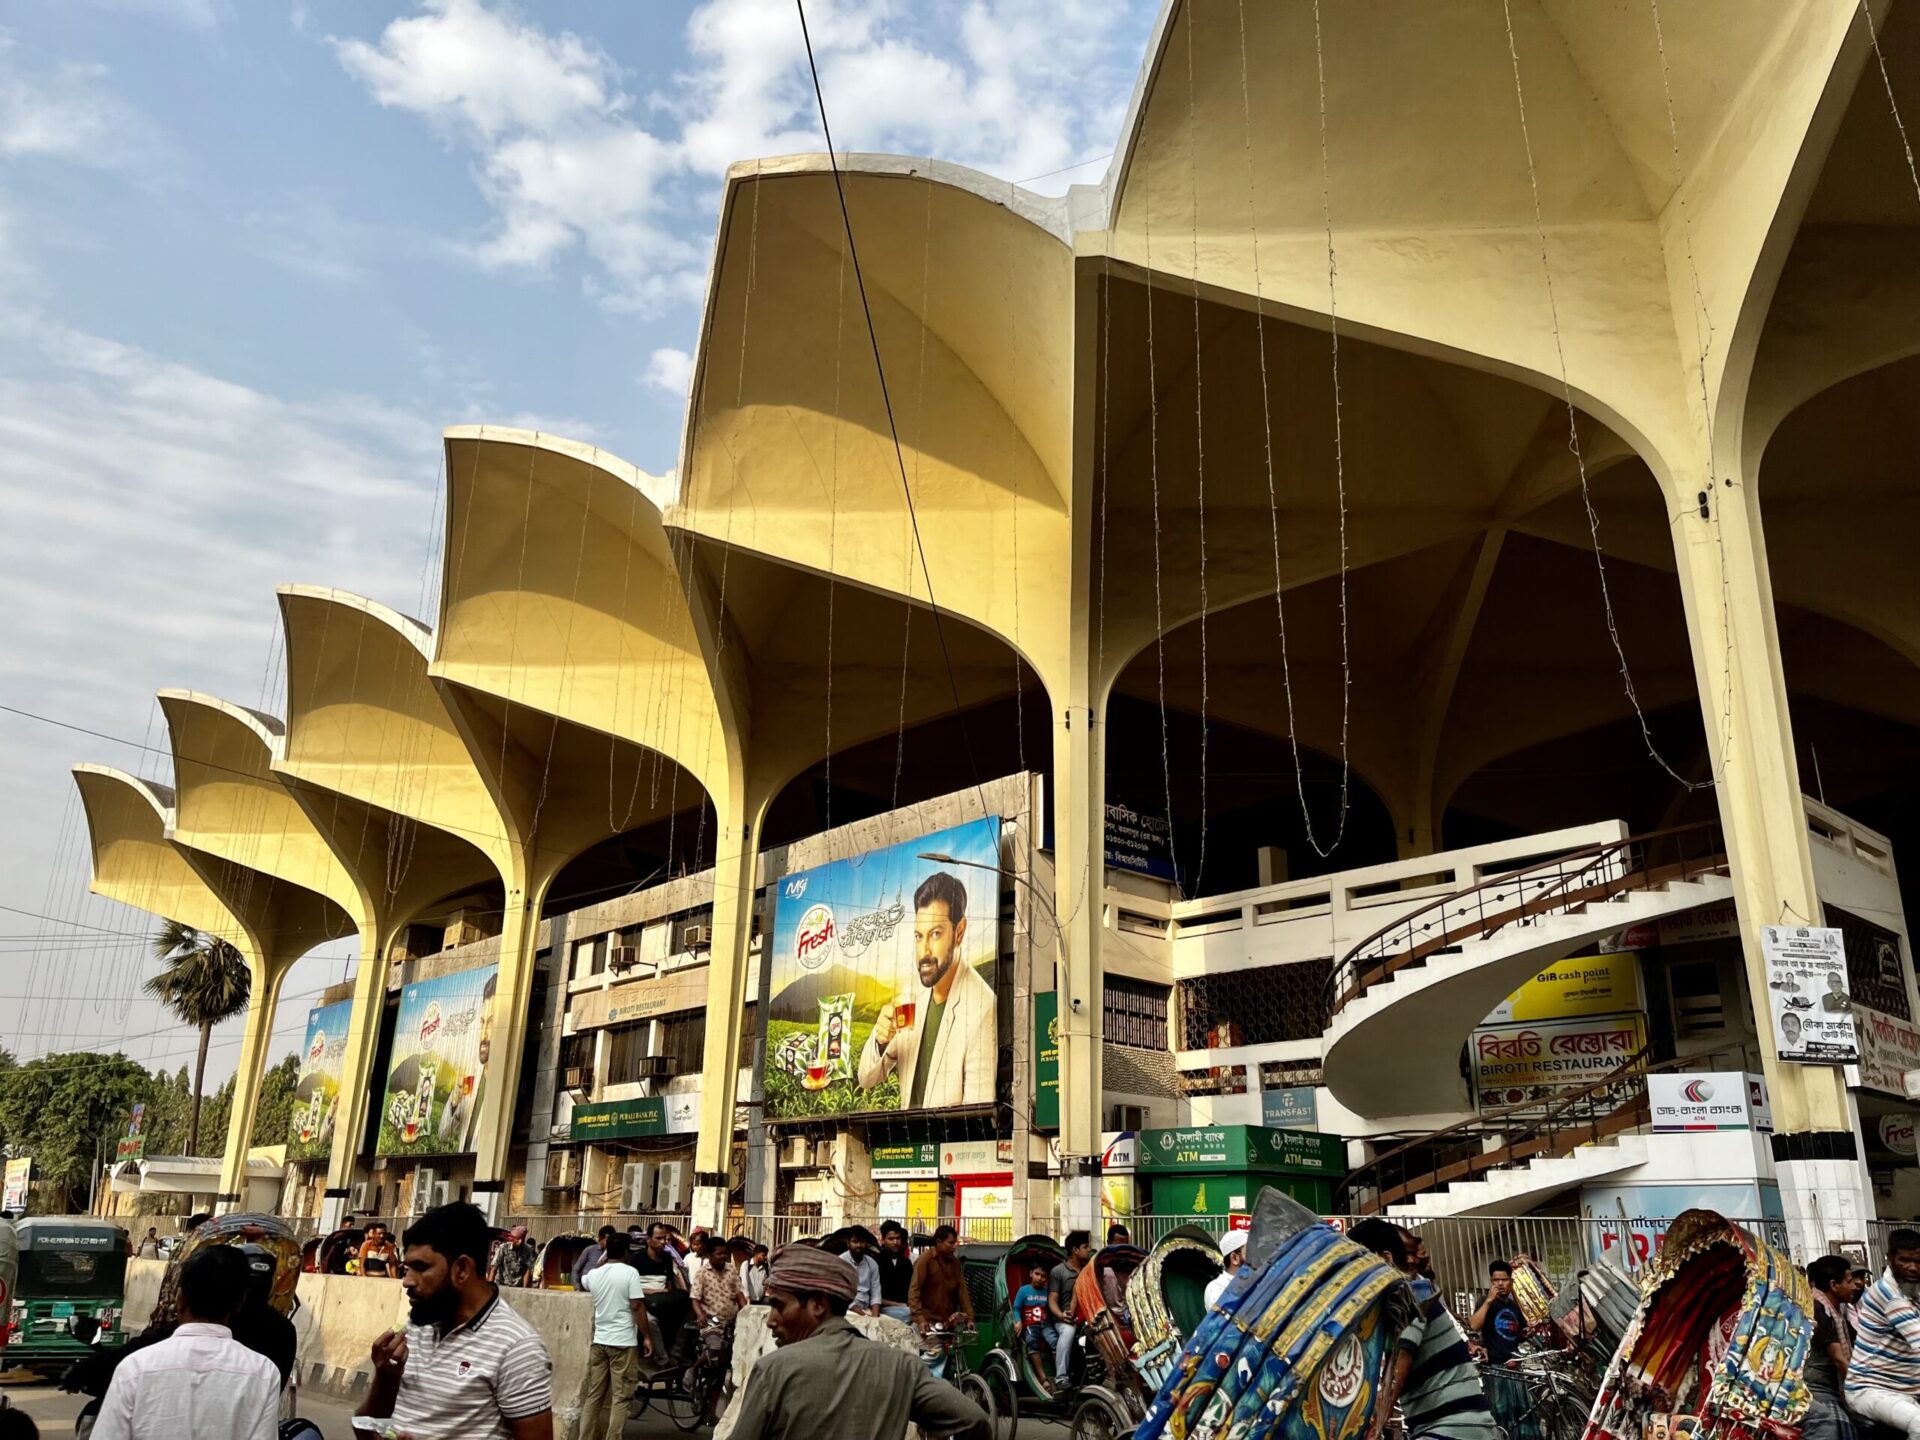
[1674,467,1874,1254]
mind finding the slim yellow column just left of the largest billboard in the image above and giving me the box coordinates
[693,785,766,1231]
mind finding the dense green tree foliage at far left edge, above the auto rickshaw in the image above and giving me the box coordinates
[0,1050,154,1204]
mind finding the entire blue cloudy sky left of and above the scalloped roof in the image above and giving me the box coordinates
[0,0,1154,1073]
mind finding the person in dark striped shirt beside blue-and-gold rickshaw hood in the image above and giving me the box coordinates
[1348,1219,1503,1440]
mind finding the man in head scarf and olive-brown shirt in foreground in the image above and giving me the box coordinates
[733,1244,993,1440]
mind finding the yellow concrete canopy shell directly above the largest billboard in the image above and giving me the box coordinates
[666,157,1075,687]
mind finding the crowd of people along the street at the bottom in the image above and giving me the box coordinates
[63,1204,1920,1440]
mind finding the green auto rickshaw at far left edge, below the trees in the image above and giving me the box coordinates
[6,1215,129,1371]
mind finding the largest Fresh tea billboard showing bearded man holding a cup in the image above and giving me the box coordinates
[766,818,1000,1117]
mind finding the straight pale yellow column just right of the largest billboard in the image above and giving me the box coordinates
[1052,705,1106,1229]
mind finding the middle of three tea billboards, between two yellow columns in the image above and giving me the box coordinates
[374,966,499,1156]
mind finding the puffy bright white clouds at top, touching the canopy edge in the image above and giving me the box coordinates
[332,0,1152,311]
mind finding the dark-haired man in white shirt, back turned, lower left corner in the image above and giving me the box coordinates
[94,1244,280,1440]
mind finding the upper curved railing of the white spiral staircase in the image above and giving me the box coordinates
[1327,820,1726,1018]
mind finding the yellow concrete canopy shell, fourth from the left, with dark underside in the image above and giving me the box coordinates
[430,426,737,872]
